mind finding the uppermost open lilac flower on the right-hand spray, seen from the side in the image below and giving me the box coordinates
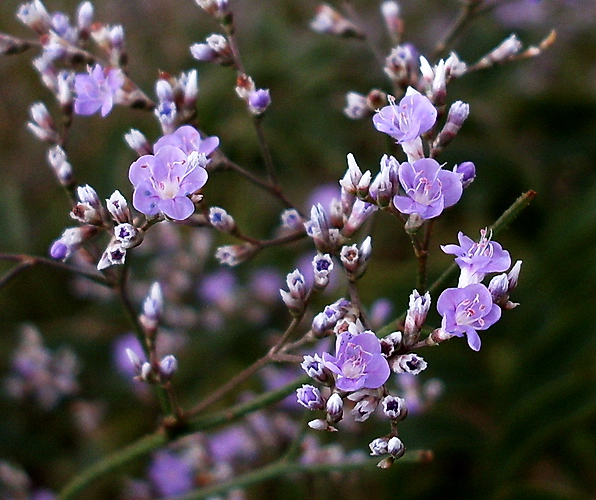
[373,87,437,143]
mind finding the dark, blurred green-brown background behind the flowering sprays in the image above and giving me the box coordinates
[0,0,596,499]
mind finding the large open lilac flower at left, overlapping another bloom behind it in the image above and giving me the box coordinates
[128,146,207,220]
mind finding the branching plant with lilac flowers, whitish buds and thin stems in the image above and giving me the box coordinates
[0,0,552,499]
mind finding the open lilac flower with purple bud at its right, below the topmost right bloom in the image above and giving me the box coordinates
[393,158,463,219]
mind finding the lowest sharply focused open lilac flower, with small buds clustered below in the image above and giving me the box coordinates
[323,331,390,392]
